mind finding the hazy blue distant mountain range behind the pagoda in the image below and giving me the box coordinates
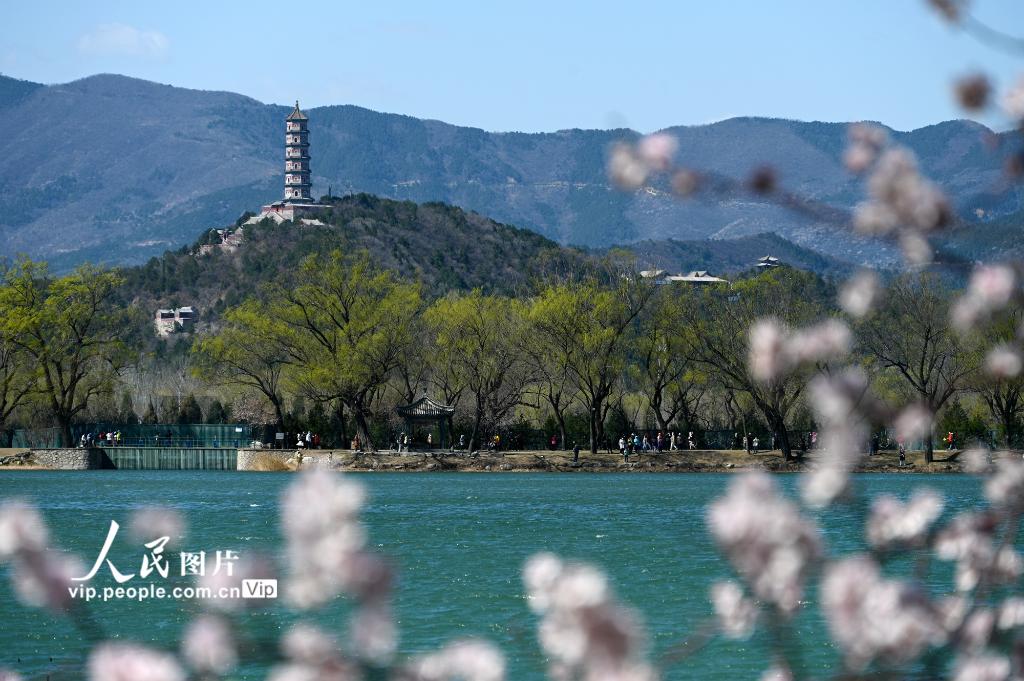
[0,75,1024,268]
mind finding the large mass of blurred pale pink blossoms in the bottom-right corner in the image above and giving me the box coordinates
[708,446,1024,681]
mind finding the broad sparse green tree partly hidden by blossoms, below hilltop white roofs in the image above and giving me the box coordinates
[679,267,829,459]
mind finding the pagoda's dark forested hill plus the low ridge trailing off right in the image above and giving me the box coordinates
[117,195,849,331]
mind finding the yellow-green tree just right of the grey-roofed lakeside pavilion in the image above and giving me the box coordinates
[425,289,529,452]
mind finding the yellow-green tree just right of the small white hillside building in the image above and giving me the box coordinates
[193,299,294,430]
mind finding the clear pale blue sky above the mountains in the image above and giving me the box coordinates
[0,0,1024,132]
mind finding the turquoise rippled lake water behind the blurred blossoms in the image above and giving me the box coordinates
[0,471,981,681]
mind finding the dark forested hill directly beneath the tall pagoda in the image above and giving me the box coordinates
[124,195,591,327]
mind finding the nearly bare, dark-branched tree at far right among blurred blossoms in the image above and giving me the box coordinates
[858,273,978,462]
